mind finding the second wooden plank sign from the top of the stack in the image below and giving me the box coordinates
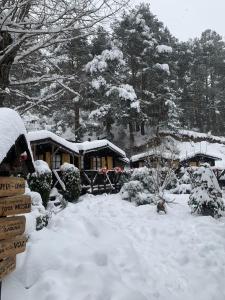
[0,195,31,217]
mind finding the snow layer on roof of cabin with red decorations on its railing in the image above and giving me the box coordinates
[76,140,126,158]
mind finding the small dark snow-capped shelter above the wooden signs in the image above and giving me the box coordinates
[0,108,34,177]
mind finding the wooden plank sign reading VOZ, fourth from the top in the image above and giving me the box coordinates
[0,235,27,259]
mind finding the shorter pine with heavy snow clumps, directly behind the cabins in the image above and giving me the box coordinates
[86,42,139,139]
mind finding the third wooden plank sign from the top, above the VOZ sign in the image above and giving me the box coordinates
[0,216,26,240]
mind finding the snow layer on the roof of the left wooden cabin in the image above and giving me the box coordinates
[28,130,79,153]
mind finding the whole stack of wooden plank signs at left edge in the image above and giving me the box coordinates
[0,177,31,280]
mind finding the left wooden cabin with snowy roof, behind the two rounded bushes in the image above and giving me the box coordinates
[28,130,80,170]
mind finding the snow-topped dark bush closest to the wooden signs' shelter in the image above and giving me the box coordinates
[27,160,52,208]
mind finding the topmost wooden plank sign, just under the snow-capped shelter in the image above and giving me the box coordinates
[0,177,25,197]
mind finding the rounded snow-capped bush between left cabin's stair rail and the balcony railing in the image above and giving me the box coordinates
[60,163,81,202]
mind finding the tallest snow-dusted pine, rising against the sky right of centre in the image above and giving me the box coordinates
[114,4,180,134]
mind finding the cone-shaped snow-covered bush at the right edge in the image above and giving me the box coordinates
[188,164,225,217]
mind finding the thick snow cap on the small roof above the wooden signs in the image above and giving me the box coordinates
[0,108,32,162]
